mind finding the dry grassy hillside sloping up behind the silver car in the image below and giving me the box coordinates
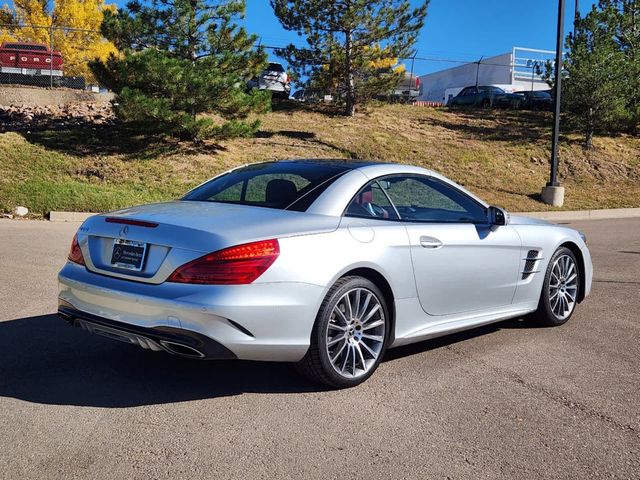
[0,105,640,214]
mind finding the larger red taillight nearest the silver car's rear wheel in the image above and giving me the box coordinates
[167,239,280,285]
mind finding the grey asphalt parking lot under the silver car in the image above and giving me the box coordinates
[0,219,640,479]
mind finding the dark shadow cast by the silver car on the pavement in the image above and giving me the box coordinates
[0,315,526,408]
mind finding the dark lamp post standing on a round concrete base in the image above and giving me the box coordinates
[542,0,564,207]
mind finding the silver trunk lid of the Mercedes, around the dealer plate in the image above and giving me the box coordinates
[78,201,340,283]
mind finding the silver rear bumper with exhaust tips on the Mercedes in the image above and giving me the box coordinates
[58,263,326,362]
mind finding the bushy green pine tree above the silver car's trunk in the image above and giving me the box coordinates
[92,0,270,140]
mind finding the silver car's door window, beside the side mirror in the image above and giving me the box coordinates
[380,176,487,223]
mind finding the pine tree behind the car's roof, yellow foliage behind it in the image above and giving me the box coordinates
[271,0,428,115]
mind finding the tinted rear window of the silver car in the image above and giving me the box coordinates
[182,161,352,211]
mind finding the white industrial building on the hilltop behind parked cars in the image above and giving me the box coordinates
[418,47,555,103]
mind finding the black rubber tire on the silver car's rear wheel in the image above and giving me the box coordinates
[296,276,391,388]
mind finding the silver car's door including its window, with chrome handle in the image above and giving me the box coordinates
[379,175,521,315]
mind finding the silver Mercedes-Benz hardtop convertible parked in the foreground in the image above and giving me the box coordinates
[58,160,593,387]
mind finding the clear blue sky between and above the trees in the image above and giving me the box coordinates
[240,0,592,74]
